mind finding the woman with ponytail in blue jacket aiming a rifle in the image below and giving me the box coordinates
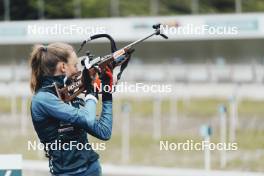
[30,43,112,176]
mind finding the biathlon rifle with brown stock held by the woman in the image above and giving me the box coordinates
[54,24,168,102]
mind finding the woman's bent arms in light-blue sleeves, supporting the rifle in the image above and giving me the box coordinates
[32,92,112,140]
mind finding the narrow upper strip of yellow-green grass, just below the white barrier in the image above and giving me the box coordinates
[0,97,264,118]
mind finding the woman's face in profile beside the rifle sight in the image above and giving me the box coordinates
[64,52,78,77]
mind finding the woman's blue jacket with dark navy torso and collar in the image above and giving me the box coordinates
[31,75,112,174]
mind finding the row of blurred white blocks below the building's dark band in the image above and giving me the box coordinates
[0,64,264,83]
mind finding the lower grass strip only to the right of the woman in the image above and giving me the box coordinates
[95,131,264,172]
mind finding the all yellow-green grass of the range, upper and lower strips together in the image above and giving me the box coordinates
[0,97,264,172]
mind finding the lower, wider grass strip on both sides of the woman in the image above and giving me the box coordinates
[0,127,264,172]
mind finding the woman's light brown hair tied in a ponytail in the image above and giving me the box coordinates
[30,43,74,93]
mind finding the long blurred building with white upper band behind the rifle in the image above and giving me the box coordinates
[0,13,264,83]
